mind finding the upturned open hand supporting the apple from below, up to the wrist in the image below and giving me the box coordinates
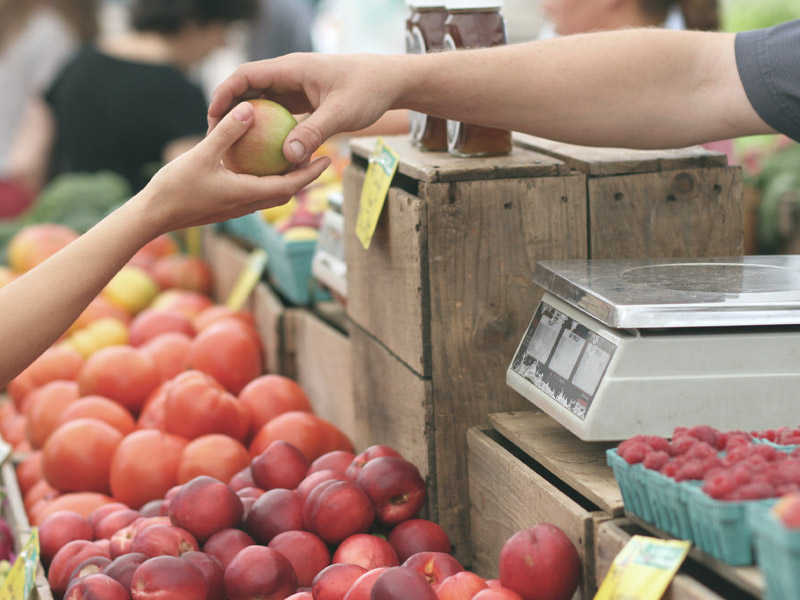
[139,104,330,233]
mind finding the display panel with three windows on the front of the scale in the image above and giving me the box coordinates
[511,302,616,420]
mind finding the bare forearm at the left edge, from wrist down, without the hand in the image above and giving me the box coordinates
[0,192,160,388]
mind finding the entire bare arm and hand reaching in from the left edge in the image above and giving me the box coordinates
[0,104,330,388]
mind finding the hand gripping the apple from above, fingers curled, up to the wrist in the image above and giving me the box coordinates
[208,54,397,164]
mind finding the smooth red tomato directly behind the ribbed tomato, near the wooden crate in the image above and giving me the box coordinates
[189,319,262,394]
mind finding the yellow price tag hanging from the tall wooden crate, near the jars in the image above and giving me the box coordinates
[356,138,400,250]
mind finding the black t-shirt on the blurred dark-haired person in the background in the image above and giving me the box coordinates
[45,48,207,192]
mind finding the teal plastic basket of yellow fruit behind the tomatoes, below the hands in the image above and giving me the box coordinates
[221,213,331,305]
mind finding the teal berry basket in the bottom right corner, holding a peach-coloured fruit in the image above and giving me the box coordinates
[748,505,800,600]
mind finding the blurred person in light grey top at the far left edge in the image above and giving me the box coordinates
[0,0,97,219]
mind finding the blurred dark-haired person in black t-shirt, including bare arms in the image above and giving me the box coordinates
[11,0,255,192]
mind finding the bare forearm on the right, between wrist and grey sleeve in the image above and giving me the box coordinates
[394,29,771,148]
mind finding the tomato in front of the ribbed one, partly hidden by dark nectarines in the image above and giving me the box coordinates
[178,433,250,483]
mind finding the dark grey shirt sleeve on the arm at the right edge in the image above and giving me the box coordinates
[736,19,800,142]
